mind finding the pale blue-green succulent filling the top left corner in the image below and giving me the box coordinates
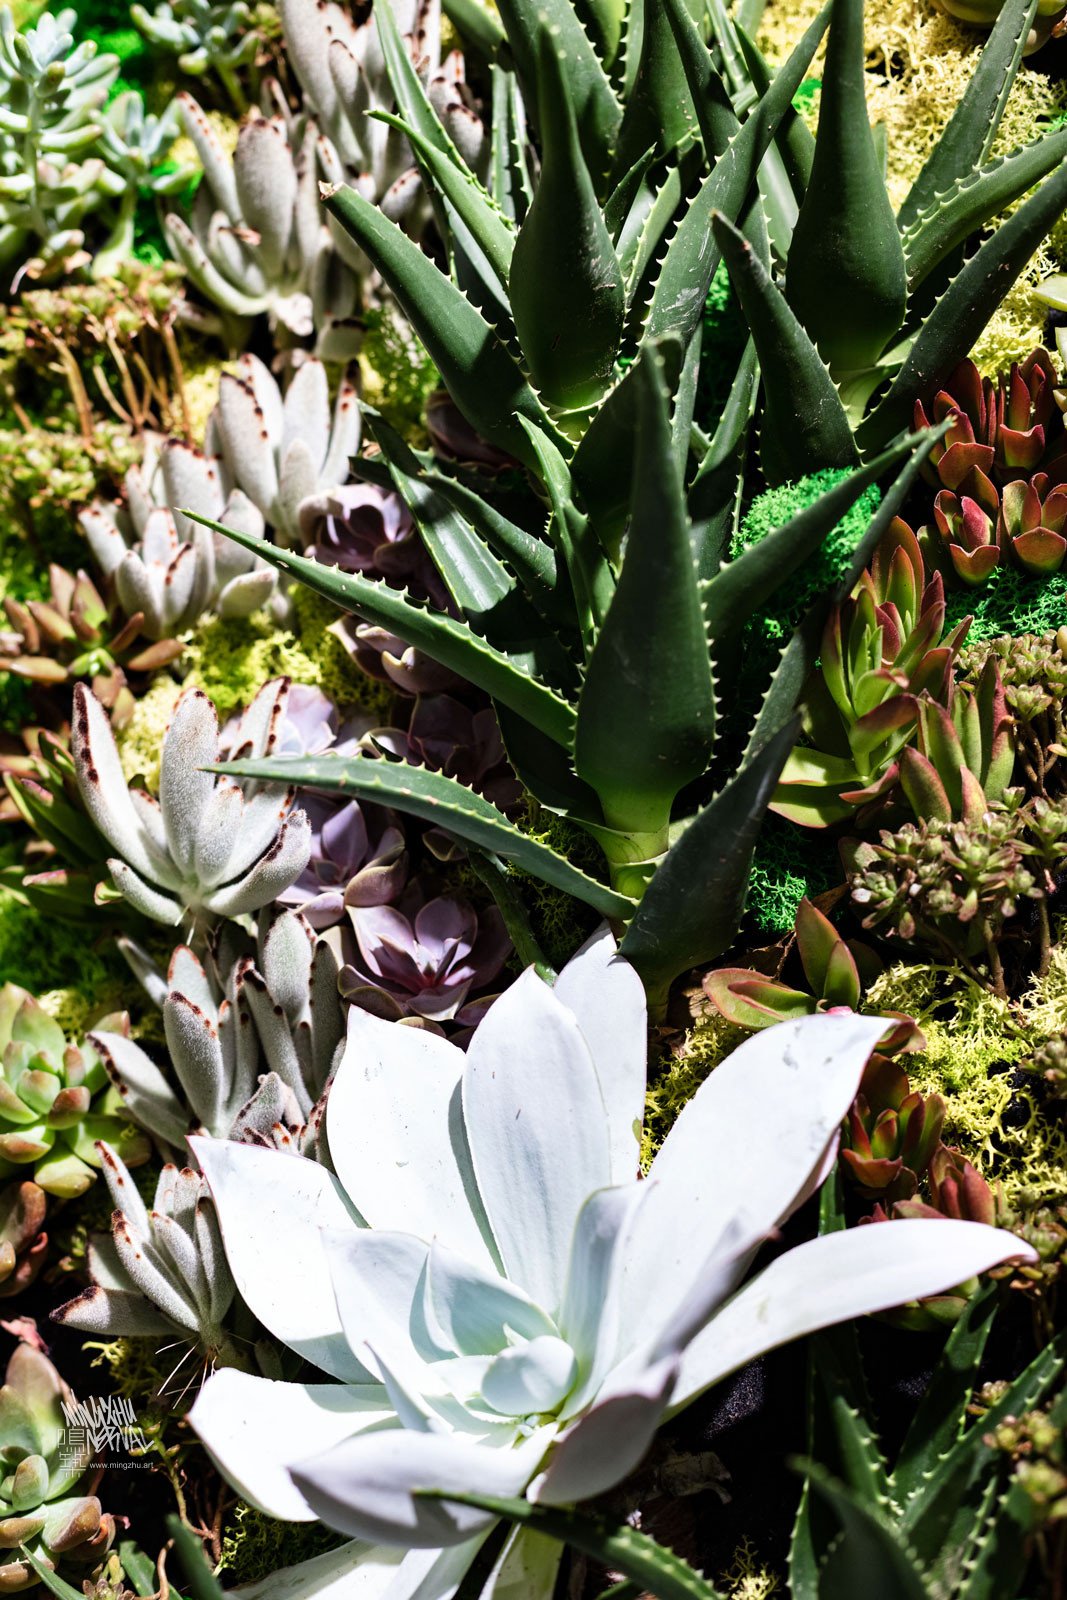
[0,5,118,275]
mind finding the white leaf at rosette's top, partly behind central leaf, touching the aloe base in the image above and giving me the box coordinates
[553,925,648,1184]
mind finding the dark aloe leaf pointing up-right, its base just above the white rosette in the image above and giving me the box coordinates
[622,720,798,1002]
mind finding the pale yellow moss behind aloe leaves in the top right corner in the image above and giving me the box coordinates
[760,0,1067,374]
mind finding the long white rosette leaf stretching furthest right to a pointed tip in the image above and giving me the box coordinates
[672,1219,1033,1411]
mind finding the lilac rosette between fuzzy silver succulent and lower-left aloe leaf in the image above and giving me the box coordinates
[278,794,408,933]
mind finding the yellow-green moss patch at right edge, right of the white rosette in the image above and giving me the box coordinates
[869,947,1067,1206]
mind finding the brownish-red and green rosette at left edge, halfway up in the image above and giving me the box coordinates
[0,563,184,717]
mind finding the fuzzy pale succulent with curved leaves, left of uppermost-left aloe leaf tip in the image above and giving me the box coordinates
[165,94,358,360]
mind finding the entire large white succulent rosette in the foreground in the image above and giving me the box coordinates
[192,931,1027,1600]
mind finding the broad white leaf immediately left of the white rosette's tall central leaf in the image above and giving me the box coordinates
[326,1006,493,1267]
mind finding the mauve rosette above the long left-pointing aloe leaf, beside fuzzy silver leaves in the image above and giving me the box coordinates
[301,483,448,610]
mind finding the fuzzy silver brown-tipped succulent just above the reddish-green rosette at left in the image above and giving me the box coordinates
[80,435,275,638]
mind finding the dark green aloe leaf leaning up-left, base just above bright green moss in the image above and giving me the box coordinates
[713,214,859,483]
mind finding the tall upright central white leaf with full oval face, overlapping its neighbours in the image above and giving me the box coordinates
[462,970,611,1314]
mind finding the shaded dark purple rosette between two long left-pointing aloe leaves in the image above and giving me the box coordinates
[373,694,523,811]
